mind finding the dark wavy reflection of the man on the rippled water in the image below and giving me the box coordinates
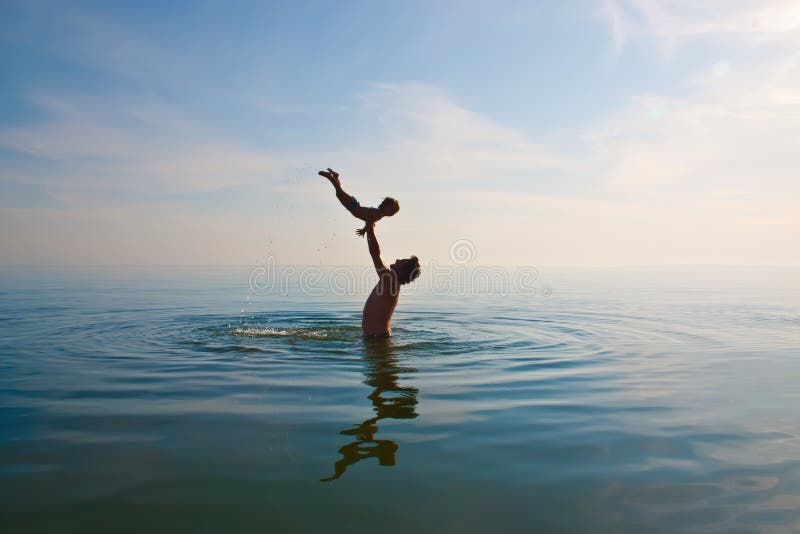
[321,338,418,482]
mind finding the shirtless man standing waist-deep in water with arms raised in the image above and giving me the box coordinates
[361,224,420,337]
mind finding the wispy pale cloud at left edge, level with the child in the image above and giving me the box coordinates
[0,95,298,194]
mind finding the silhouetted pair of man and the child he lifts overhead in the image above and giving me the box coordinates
[319,168,420,338]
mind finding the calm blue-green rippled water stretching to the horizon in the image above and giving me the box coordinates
[0,268,800,532]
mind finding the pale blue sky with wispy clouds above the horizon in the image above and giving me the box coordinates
[0,0,800,266]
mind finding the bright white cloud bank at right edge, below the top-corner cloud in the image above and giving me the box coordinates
[588,55,800,200]
